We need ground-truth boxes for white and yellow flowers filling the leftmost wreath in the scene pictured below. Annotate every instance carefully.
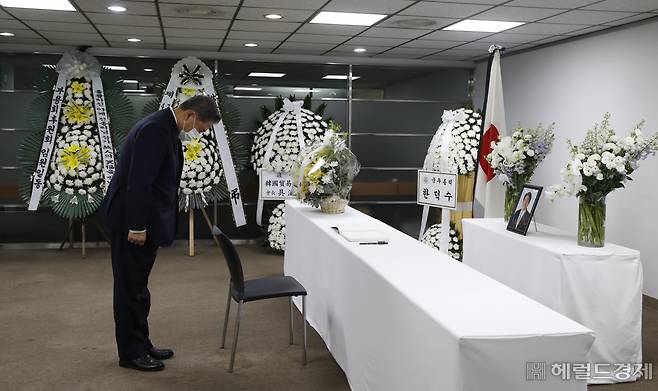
[48,79,105,205]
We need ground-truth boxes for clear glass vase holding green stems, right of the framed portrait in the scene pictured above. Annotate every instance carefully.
[578,197,605,247]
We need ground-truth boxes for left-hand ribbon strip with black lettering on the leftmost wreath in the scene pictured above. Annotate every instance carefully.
[27,73,67,211]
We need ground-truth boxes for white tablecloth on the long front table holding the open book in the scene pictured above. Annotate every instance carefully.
[284,201,594,391]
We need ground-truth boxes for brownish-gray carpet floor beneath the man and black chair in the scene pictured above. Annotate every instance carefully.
[0,243,658,391]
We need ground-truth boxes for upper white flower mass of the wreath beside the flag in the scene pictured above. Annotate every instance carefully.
[433,109,482,175]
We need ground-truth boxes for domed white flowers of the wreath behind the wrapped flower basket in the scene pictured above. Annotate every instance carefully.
[251,109,327,173]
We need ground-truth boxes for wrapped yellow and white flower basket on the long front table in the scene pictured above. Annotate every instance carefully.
[293,123,361,213]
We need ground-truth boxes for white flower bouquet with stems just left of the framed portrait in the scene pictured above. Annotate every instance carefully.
[487,124,555,221]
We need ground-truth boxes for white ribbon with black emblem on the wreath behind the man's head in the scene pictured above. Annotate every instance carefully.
[160,57,247,227]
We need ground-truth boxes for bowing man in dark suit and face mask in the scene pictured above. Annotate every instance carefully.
[102,95,220,371]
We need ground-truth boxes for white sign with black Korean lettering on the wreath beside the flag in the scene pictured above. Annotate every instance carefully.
[416,170,457,210]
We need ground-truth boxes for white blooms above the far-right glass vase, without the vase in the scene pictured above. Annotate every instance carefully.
[546,113,658,200]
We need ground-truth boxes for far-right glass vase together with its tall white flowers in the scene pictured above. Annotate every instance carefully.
[546,113,658,247]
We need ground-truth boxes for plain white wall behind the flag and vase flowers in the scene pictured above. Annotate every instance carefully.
[475,20,658,298]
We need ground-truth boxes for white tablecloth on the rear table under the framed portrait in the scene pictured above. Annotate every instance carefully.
[463,219,642,383]
